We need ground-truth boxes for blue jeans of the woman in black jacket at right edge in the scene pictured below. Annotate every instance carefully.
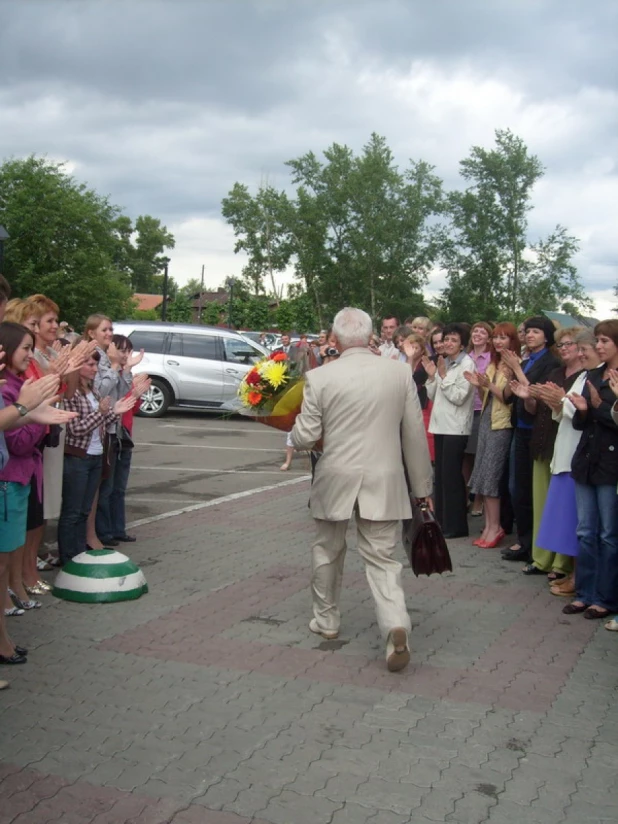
[575,483,618,612]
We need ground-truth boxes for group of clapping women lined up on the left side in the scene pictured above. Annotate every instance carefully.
[0,276,150,686]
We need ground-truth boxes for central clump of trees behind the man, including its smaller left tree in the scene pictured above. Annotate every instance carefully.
[223,134,442,326]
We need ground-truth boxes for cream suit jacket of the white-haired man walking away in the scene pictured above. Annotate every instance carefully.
[292,347,433,521]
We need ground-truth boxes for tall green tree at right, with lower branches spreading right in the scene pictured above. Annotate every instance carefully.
[439,130,590,321]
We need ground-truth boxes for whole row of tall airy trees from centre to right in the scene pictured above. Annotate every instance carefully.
[223,130,590,328]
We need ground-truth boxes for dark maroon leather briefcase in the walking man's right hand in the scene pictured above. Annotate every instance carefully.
[402,500,453,578]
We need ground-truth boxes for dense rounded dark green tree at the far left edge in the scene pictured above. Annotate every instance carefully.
[0,156,132,327]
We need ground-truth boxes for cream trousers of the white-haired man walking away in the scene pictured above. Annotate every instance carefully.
[311,513,411,640]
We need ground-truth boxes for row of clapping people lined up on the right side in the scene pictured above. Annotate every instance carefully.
[381,316,618,630]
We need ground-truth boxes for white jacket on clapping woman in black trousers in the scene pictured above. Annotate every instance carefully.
[425,354,476,435]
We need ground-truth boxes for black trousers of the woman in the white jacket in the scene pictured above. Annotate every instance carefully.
[434,435,468,537]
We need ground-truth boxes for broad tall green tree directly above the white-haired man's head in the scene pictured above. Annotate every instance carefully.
[288,134,442,325]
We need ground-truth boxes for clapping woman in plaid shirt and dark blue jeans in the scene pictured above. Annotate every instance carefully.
[58,351,136,564]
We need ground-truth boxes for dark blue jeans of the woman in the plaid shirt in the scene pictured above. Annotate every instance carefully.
[58,455,103,564]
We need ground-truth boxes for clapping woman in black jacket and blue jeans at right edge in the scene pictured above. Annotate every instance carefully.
[562,320,618,619]
